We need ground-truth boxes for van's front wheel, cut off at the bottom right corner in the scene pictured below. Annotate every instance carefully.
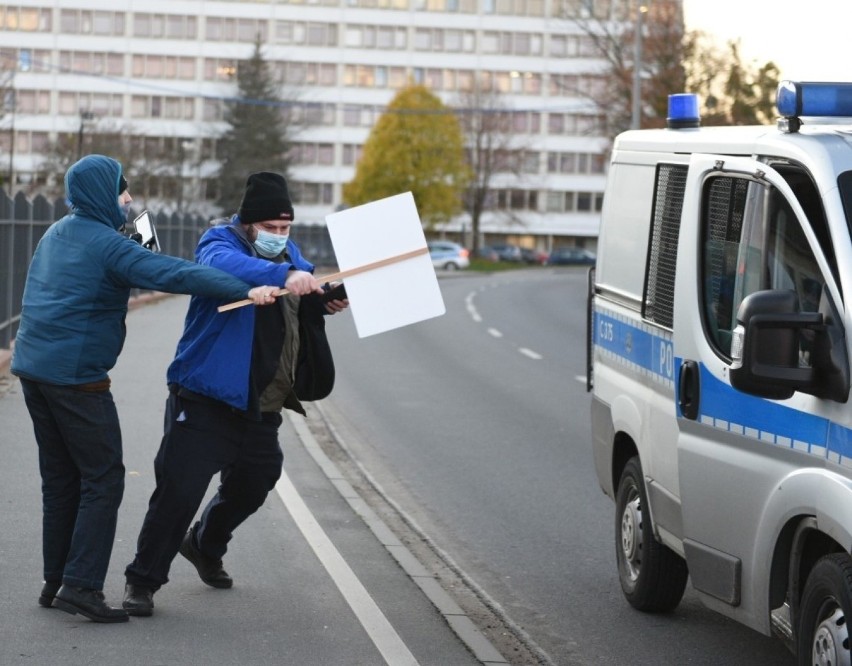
[797,553,852,666]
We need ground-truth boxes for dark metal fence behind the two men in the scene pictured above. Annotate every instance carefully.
[0,190,335,349]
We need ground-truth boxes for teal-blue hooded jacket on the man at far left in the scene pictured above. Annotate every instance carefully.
[11,155,249,385]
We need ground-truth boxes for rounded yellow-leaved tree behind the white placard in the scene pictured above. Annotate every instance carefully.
[343,85,470,225]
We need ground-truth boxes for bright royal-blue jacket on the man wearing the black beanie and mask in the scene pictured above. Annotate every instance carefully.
[167,216,314,410]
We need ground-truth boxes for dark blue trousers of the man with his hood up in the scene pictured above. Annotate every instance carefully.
[21,378,124,590]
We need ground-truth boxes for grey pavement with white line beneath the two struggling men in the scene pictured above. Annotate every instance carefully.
[0,297,507,666]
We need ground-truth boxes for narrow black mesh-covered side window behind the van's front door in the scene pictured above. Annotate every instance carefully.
[643,164,687,328]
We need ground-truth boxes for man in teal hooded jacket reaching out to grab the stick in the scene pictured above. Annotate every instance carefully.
[11,155,276,622]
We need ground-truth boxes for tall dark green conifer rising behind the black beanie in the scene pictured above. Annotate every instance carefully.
[216,39,295,213]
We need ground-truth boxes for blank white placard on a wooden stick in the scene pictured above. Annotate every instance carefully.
[325,192,446,338]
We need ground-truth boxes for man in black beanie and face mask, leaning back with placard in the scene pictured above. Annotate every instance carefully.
[123,172,348,616]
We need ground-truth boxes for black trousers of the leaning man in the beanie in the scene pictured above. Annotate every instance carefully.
[125,393,284,590]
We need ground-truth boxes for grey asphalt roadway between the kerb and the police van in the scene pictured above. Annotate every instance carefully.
[320,268,793,666]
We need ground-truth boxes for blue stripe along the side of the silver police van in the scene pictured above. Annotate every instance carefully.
[593,310,852,464]
